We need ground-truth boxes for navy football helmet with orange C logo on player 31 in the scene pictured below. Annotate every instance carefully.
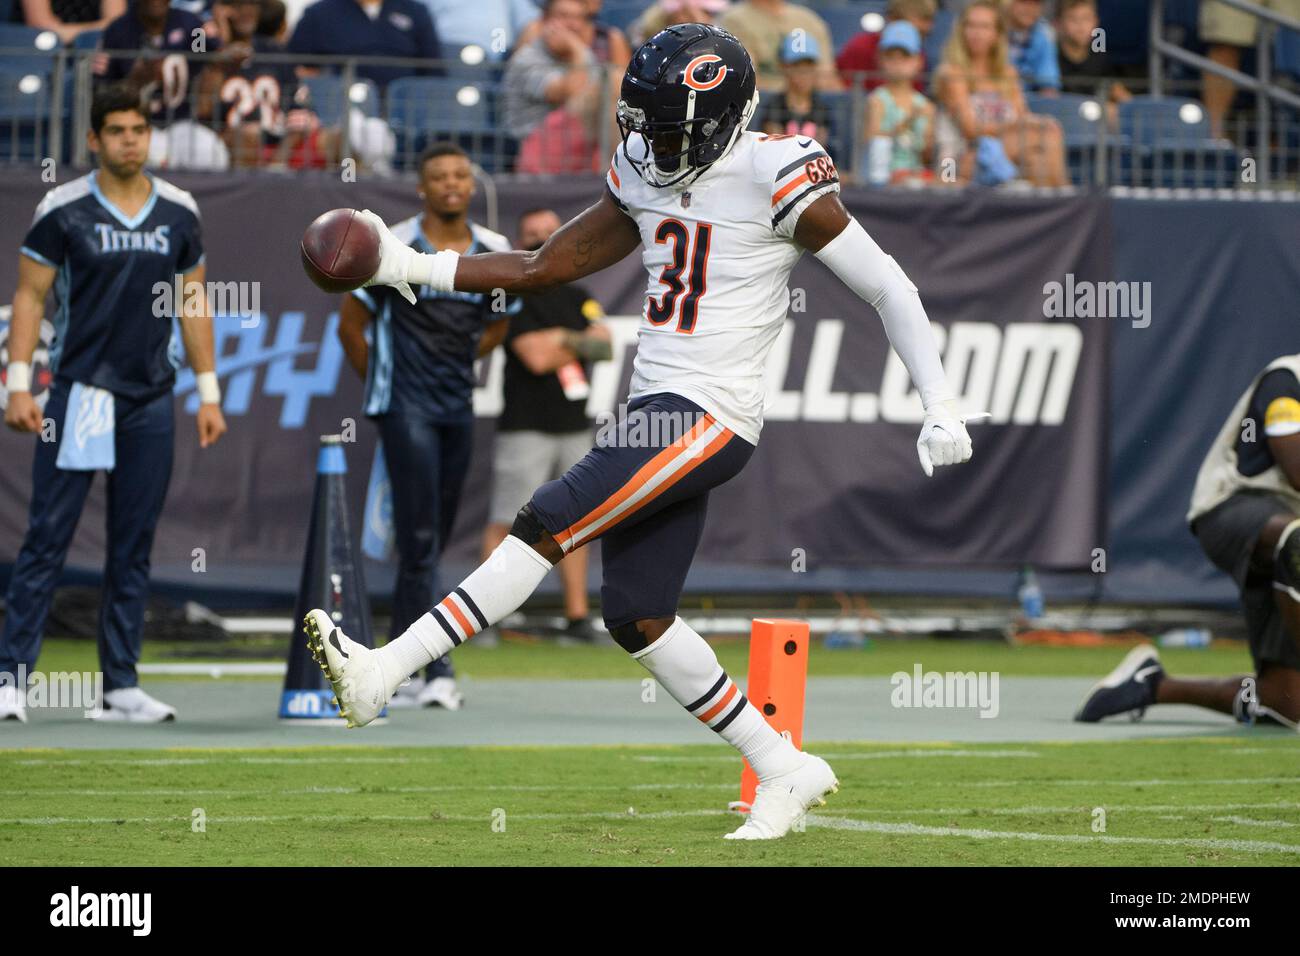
[618,23,758,187]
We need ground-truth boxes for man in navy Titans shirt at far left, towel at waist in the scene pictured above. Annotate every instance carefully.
[0,86,226,722]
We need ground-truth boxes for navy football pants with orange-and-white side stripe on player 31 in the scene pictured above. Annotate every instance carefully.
[529,393,754,628]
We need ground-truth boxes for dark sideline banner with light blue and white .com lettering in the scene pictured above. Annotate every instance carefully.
[12,167,1289,589]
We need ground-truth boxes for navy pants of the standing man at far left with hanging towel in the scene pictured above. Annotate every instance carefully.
[0,380,176,691]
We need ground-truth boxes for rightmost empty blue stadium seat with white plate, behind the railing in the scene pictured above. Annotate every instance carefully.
[1119,96,1238,187]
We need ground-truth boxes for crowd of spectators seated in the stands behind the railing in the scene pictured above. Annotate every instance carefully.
[12,0,1300,186]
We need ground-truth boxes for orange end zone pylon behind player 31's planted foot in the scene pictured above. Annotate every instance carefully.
[731,618,809,813]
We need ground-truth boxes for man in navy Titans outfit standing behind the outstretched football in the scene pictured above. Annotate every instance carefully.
[338,144,517,710]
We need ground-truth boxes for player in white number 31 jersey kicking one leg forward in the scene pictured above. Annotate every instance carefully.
[306,23,971,839]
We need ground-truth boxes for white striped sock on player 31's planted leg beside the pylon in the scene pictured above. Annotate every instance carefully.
[632,618,801,780]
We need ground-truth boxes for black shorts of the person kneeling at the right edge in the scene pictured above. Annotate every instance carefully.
[1192,492,1300,672]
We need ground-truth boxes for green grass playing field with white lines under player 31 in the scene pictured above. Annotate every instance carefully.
[0,641,1300,866]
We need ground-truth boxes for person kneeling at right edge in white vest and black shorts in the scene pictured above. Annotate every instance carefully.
[1076,355,1300,726]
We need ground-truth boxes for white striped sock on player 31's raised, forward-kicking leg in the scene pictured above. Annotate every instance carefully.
[380,535,551,676]
